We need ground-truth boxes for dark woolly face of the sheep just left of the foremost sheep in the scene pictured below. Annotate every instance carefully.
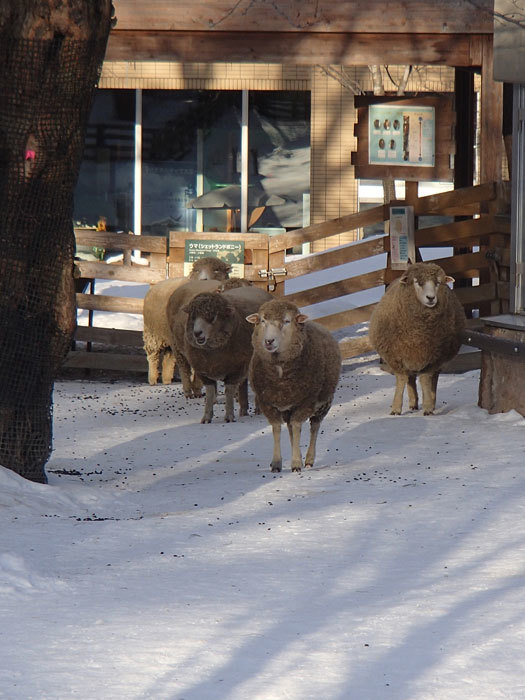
[183,293,235,349]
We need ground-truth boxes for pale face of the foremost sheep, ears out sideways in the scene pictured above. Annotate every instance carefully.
[246,301,308,356]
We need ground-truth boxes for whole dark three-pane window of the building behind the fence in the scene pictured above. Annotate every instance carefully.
[74,90,310,235]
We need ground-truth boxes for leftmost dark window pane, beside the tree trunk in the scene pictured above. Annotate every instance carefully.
[73,90,135,231]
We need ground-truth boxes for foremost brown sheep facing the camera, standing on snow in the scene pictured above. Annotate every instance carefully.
[246,299,341,472]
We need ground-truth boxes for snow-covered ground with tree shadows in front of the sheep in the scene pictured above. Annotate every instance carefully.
[0,266,525,700]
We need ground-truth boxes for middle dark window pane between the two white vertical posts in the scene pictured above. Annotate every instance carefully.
[142,90,241,235]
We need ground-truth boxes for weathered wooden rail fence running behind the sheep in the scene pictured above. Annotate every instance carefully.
[65,183,510,372]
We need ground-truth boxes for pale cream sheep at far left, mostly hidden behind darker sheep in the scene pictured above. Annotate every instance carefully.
[142,256,231,385]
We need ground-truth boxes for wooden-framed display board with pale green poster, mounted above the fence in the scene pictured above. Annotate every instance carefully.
[352,96,455,181]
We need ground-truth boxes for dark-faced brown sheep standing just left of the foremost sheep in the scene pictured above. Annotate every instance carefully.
[168,287,272,423]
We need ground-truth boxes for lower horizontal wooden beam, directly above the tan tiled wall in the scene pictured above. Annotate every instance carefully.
[105,30,484,66]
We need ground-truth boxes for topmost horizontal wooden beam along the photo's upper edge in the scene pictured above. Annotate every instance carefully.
[113,0,493,34]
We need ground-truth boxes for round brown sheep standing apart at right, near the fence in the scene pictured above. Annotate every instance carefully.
[369,263,466,416]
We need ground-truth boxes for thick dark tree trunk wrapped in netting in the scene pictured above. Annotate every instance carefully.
[0,0,112,482]
